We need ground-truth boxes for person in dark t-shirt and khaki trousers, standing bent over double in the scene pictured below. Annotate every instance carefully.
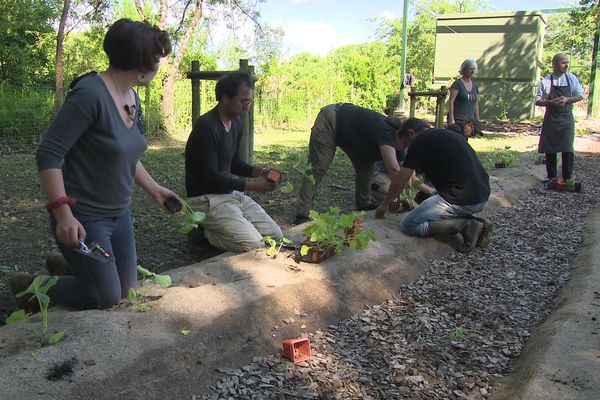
[293,103,401,224]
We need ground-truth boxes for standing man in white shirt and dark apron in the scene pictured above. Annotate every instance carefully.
[535,53,583,181]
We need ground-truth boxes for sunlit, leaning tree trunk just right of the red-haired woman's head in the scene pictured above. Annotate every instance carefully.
[160,0,202,133]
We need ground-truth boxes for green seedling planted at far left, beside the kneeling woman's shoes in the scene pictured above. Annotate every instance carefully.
[6,275,65,348]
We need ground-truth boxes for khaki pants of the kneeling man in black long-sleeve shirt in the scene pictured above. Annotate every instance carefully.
[188,192,283,253]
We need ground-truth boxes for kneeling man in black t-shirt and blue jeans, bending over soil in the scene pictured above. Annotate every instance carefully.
[375,118,492,252]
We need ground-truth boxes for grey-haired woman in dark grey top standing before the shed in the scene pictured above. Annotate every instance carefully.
[448,59,479,126]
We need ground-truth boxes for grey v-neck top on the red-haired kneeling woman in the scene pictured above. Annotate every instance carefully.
[36,74,147,217]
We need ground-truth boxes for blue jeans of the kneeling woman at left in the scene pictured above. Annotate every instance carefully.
[48,211,137,310]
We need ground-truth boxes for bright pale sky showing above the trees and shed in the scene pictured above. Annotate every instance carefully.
[260,0,576,56]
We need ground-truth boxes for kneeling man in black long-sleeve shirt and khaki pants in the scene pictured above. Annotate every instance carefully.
[185,72,283,253]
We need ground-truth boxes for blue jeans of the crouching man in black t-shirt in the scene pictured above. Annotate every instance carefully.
[400,194,487,237]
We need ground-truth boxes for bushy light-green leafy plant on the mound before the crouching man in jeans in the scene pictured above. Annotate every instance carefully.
[300,207,376,256]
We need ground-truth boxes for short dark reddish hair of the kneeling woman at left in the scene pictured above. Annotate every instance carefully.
[103,18,171,72]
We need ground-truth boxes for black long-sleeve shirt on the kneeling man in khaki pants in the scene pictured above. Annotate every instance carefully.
[185,107,253,197]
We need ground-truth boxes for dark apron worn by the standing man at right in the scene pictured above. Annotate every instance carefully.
[538,75,575,154]
